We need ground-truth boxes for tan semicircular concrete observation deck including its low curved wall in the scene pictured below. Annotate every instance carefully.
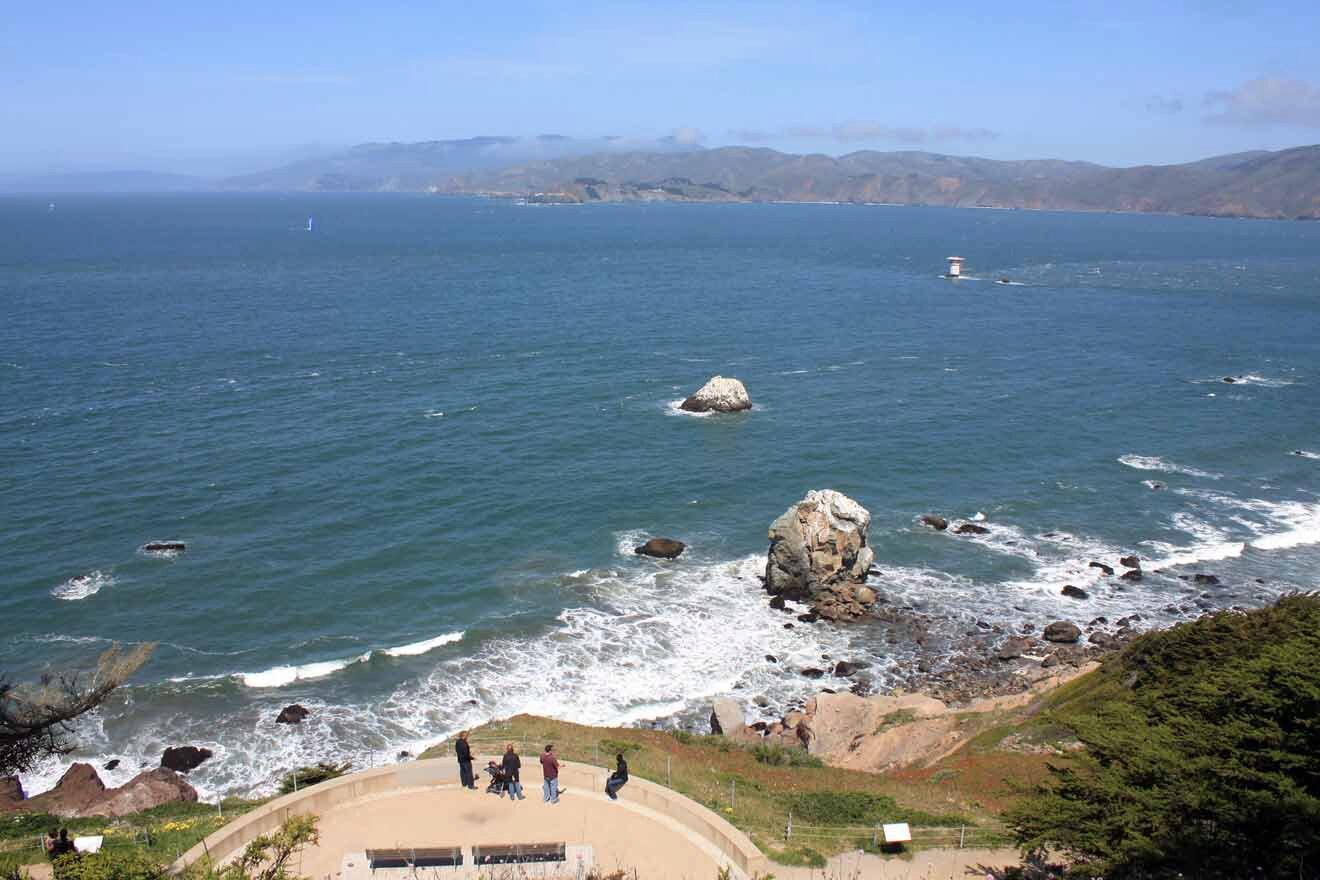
[173,755,770,880]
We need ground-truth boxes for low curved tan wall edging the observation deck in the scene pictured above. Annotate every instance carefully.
[170,757,770,877]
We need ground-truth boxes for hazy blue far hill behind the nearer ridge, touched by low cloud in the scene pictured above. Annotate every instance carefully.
[219,135,696,193]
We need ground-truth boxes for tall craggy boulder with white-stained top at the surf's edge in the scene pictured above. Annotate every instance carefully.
[766,489,875,620]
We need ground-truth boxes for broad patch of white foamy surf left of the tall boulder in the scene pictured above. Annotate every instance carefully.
[380,556,865,734]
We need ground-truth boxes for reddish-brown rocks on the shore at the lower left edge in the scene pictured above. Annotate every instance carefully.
[0,763,197,819]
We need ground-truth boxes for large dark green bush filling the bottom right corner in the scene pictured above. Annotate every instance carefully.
[1010,595,1320,880]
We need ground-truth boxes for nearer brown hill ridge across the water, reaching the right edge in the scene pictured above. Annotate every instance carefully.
[438,145,1320,219]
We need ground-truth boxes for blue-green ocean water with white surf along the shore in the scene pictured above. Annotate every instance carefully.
[0,195,1320,794]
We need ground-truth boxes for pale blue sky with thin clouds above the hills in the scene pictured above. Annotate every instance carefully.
[0,0,1320,175]
